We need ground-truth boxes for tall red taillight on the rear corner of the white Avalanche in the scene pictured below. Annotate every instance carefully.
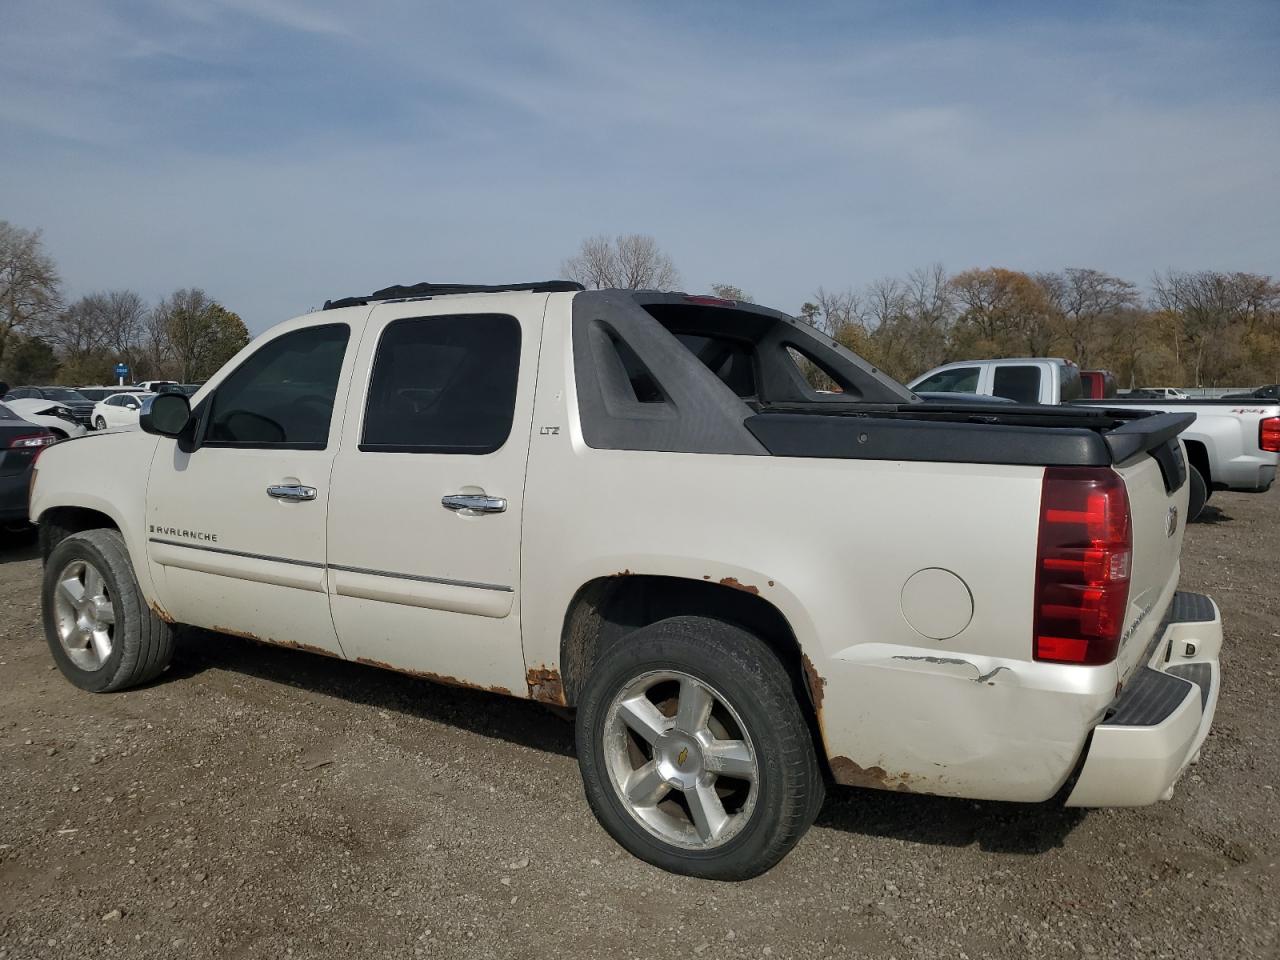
[1034,467,1133,664]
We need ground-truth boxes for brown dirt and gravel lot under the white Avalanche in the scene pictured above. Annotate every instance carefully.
[0,493,1280,960]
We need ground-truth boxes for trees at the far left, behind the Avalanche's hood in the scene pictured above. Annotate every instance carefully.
[0,220,250,385]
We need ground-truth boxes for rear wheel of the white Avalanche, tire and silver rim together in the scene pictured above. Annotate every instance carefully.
[577,617,823,879]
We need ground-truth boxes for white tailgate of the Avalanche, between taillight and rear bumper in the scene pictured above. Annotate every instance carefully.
[1115,439,1189,681]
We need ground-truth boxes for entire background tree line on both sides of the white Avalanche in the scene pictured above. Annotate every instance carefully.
[0,220,1280,387]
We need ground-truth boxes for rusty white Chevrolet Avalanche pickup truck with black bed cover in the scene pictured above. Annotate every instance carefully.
[31,282,1222,879]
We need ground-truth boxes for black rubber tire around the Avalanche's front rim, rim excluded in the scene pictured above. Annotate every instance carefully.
[41,530,173,694]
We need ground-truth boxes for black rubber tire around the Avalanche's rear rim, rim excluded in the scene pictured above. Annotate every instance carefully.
[576,617,824,881]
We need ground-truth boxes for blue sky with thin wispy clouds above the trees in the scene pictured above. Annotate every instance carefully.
[0,0,1280,332]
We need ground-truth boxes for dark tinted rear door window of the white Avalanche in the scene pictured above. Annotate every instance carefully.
[360,314,520,454]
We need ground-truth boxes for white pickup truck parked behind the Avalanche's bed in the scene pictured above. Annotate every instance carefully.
[910,357,1280,520]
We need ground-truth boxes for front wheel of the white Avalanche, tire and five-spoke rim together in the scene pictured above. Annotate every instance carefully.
[41,530,173,692]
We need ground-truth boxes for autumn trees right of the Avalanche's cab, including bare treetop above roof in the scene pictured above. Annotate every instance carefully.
[562,236,1280,387]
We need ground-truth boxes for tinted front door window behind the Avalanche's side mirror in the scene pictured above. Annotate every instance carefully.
[205,324,349,449]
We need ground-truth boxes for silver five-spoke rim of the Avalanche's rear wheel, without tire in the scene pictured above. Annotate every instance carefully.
[603,671,760,850]
